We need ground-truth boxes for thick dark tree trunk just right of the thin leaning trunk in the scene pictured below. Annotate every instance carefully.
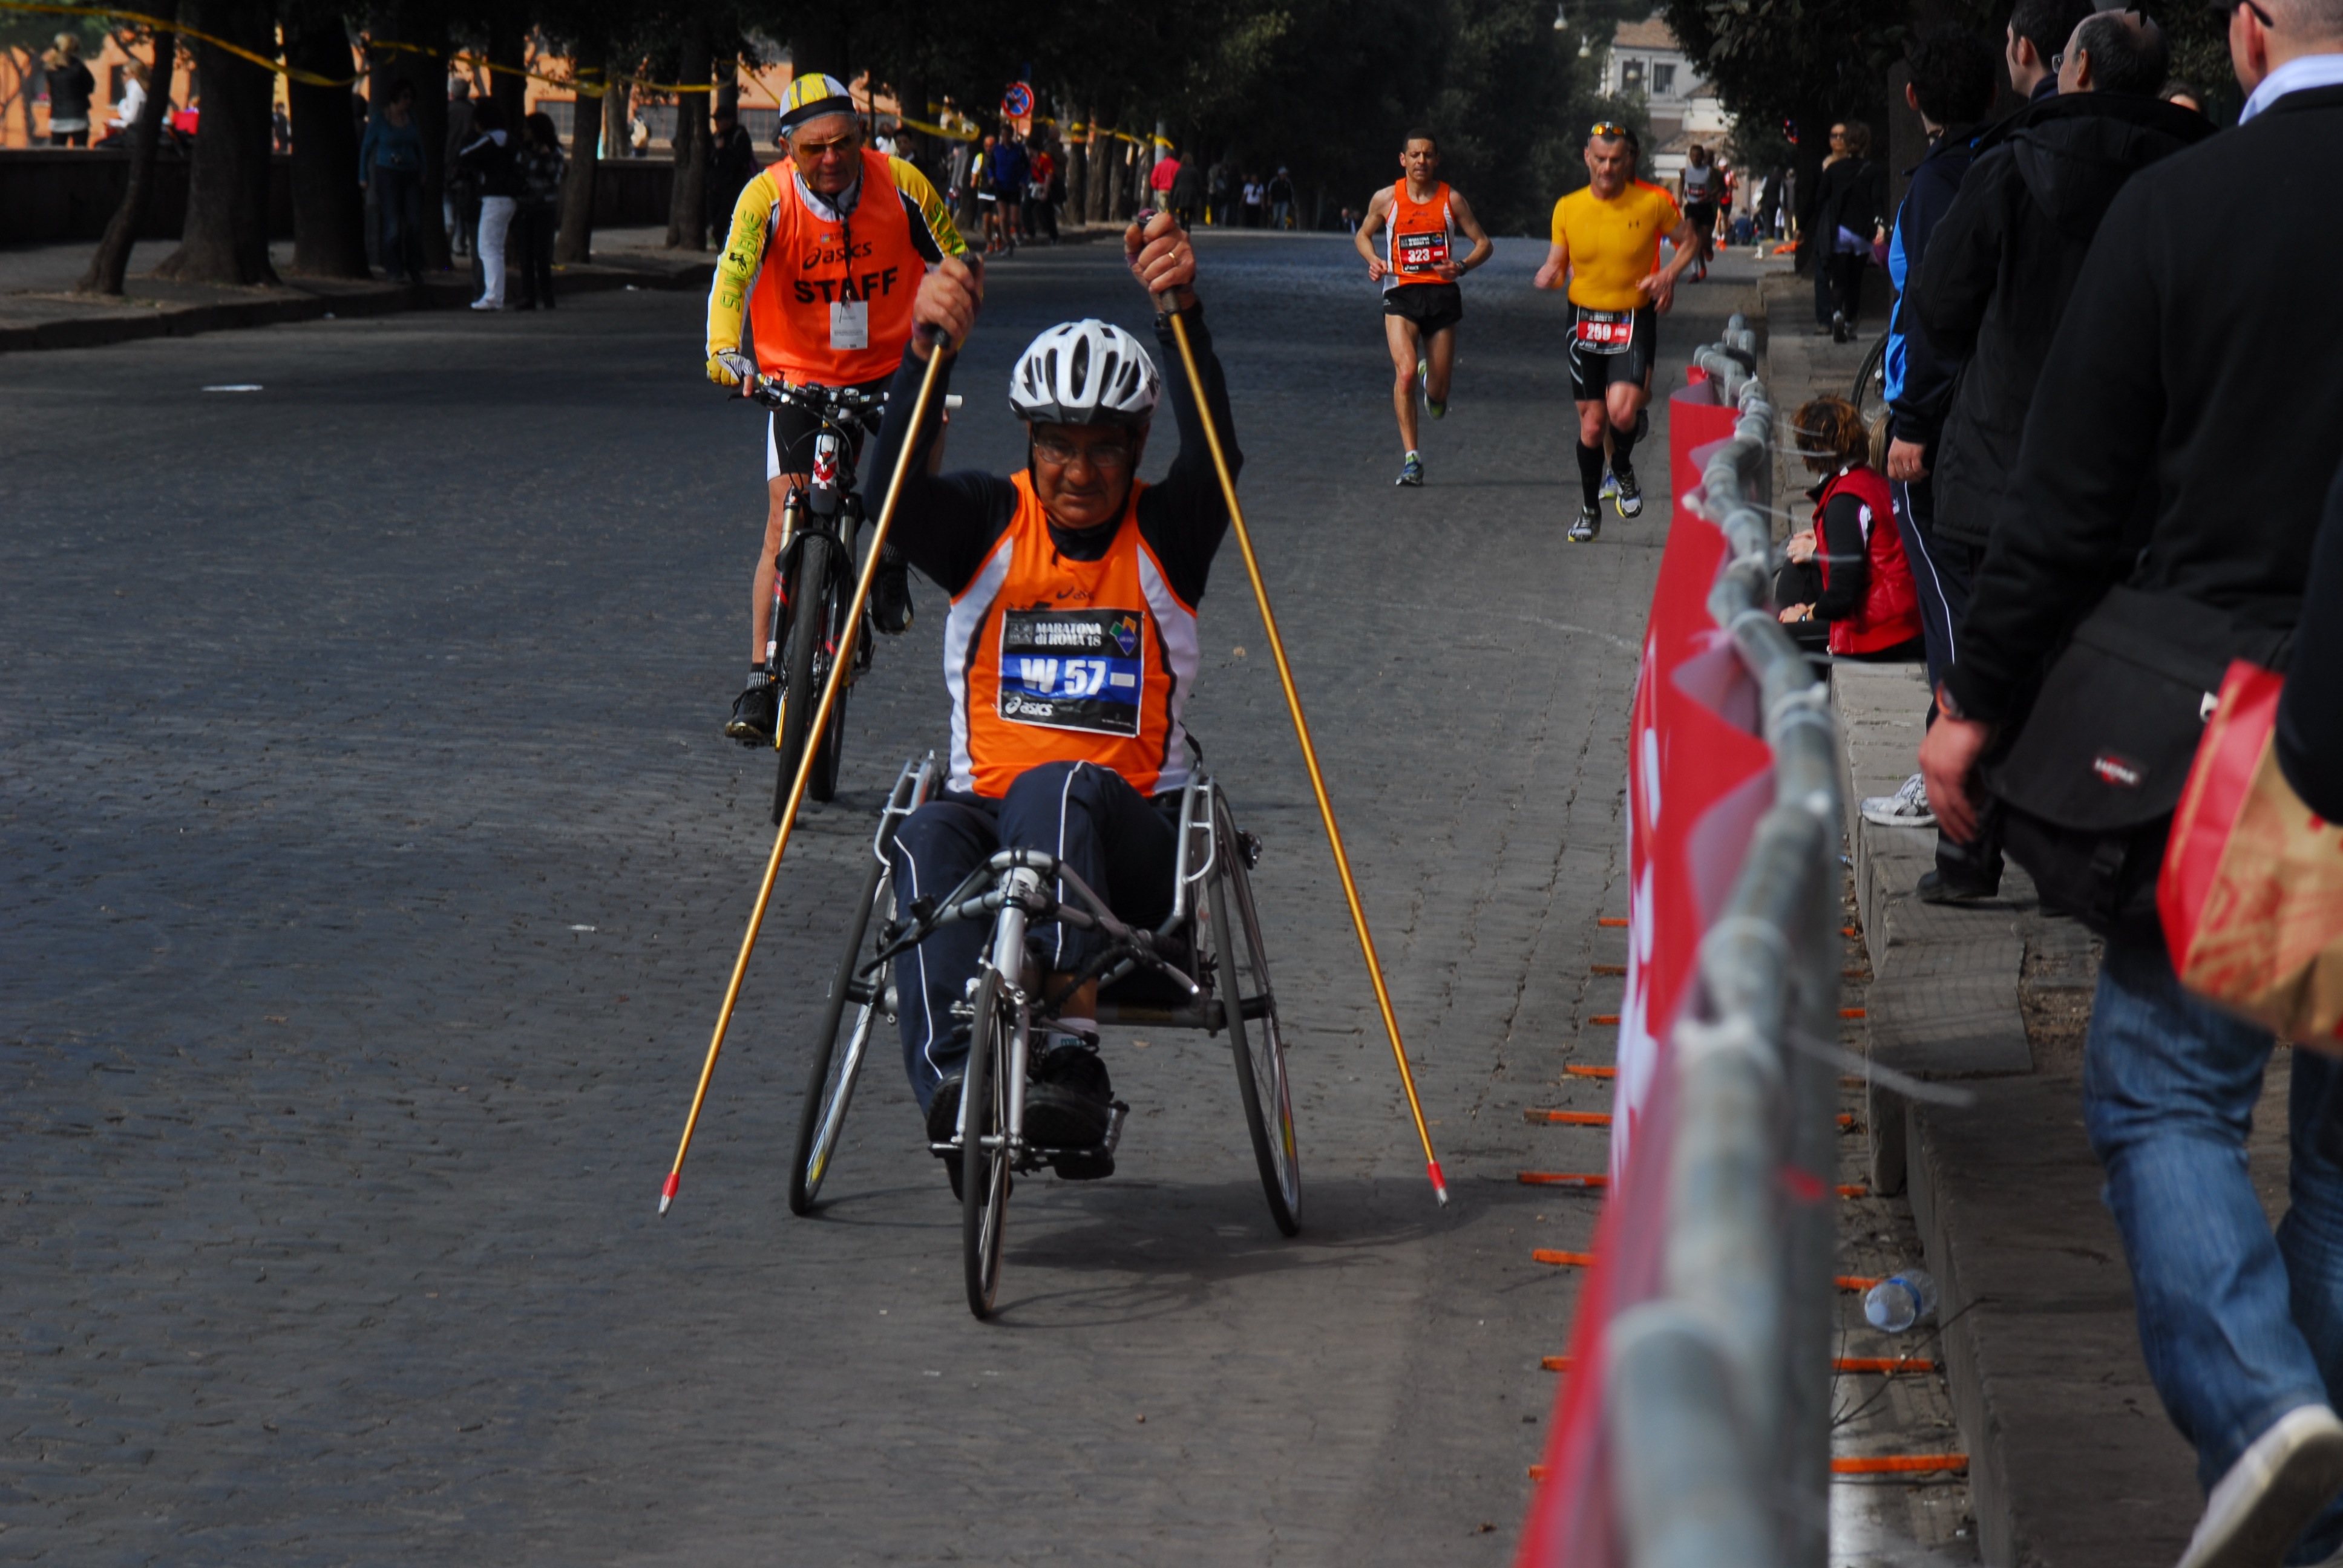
[155,0,278,286]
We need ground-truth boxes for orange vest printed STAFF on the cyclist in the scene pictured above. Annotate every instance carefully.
[747,148,928,387]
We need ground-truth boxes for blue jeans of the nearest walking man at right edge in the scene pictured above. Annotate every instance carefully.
[2083,940,2343,1563]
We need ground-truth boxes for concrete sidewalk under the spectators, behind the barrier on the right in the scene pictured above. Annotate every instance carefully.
[1766,279,2287,1568]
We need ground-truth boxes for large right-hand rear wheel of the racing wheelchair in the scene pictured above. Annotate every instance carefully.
[1207,792,1303,1235]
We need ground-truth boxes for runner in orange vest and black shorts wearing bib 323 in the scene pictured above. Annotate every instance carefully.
[1352,131,1497,485]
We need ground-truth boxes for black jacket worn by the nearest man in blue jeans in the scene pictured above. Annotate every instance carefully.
[1928,87,2343,727]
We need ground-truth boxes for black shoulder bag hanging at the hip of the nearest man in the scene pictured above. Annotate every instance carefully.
[1985,588,2289,940]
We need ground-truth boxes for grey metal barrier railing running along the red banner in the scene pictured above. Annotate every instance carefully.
[1605,316,1840,1568]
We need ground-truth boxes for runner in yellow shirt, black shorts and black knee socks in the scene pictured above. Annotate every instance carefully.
[1535,122,1701,544]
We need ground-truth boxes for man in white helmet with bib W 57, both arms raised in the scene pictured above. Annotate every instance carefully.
[874,214,1239,1191]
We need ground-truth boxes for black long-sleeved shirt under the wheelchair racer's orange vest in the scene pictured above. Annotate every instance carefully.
[865,309,1244,607]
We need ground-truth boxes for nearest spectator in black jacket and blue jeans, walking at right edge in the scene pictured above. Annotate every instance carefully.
[1921,0,2343,1568]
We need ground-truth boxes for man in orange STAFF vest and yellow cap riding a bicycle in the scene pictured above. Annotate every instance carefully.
[707,75,968,745]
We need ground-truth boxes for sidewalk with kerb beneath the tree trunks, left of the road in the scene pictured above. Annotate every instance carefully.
[0,230,715,354]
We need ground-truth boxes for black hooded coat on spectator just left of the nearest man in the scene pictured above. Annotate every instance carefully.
[1912,94,2212,549]
